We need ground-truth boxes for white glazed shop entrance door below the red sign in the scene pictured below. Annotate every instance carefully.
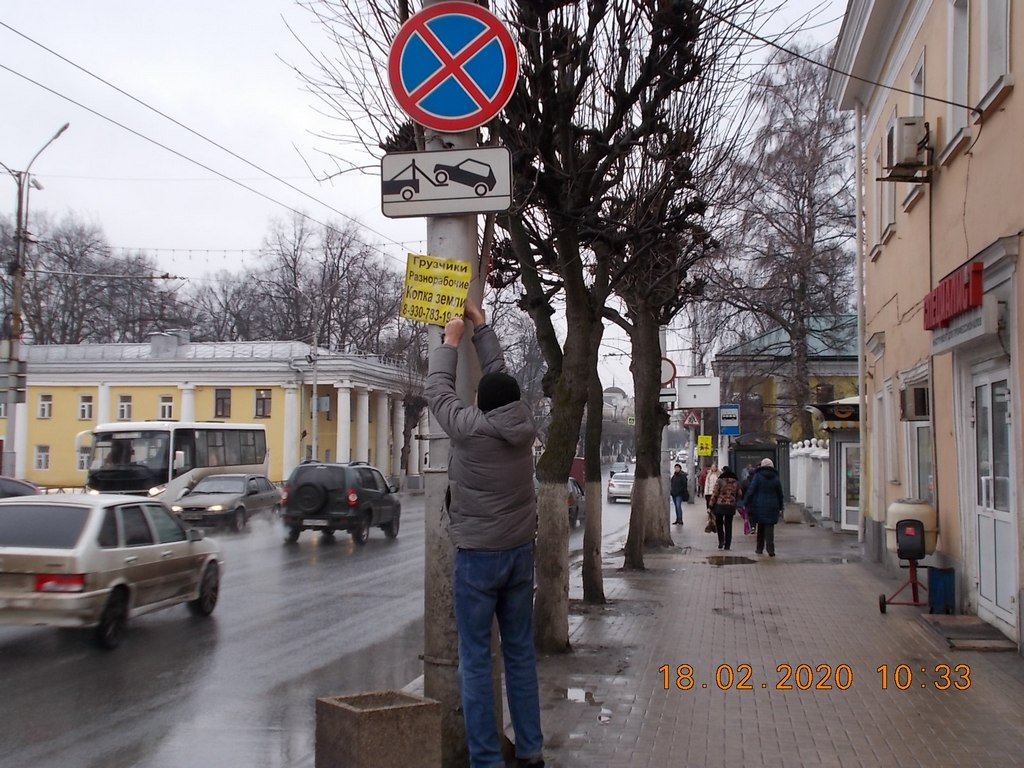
[973,369,1017,639]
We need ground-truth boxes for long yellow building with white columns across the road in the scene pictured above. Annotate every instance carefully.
[0,331,425,487]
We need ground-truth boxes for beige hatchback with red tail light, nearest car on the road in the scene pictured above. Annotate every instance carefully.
[0,494,224,648]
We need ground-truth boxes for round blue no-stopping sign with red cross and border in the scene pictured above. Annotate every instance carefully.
[388,1,519,133]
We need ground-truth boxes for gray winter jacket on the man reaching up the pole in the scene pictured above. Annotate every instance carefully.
[424,325,537,550]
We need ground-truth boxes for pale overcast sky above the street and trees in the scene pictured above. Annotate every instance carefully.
[0,0,846,391]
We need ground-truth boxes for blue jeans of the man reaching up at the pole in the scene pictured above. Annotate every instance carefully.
[455,544,544,768]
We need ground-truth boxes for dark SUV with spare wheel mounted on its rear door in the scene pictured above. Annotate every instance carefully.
[281,462,401,544]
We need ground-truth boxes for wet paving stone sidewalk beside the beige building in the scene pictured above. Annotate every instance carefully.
[540,505,1024,768]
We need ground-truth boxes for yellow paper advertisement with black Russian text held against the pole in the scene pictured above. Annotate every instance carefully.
[398,253,472,328]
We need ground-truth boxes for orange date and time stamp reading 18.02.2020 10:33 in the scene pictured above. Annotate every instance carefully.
[657,664,971,690]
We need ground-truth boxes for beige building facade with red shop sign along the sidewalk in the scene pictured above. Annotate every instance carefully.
[829,0,1024,646]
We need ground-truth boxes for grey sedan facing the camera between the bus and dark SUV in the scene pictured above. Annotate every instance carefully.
[171,474,281,530]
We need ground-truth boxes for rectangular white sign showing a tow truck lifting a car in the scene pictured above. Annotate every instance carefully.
[381,146,512,218]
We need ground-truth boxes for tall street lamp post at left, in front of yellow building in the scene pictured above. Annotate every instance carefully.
[0,123,71,476]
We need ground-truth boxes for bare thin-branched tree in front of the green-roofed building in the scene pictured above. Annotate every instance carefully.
[708,49,855,437]
